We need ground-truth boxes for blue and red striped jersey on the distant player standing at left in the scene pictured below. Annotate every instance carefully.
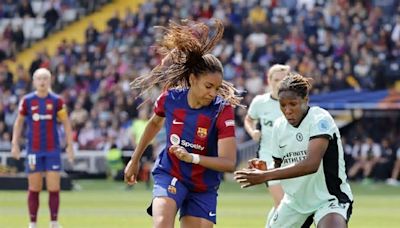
[19,92,64,153]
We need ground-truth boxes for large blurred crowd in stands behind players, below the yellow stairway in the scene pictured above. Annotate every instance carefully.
[0,0,400,183]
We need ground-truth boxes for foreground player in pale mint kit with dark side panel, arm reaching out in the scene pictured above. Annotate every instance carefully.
[235,73,353,227]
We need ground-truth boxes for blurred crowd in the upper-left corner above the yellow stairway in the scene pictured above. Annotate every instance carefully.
[0,0,109,62]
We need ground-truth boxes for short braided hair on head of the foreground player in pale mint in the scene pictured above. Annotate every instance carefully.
[278,72,312,98]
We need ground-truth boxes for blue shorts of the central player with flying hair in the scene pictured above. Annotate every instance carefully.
[148,173,218,224]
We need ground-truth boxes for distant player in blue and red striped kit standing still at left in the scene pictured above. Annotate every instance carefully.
[11,68,74,228]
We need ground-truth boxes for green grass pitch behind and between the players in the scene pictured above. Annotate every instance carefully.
[0,180,400,228]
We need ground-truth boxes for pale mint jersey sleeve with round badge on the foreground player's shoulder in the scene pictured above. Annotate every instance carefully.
[310,112,336,139]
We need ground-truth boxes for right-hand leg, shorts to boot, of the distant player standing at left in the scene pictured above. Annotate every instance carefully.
[45,156,61,228]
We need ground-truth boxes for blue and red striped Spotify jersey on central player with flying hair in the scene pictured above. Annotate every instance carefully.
[154,89,235,192]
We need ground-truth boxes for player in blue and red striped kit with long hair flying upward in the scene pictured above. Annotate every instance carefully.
[125,21,240,228]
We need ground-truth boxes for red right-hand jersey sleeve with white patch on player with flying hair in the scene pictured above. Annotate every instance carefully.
[216,105,235,139]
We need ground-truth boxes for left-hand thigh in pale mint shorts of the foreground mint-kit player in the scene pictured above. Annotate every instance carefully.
[268,201,312,228]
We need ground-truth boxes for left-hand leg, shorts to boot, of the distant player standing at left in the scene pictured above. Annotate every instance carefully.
[25,154,44,228]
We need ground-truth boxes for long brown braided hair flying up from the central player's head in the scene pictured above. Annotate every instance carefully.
[131,20,242,106]
